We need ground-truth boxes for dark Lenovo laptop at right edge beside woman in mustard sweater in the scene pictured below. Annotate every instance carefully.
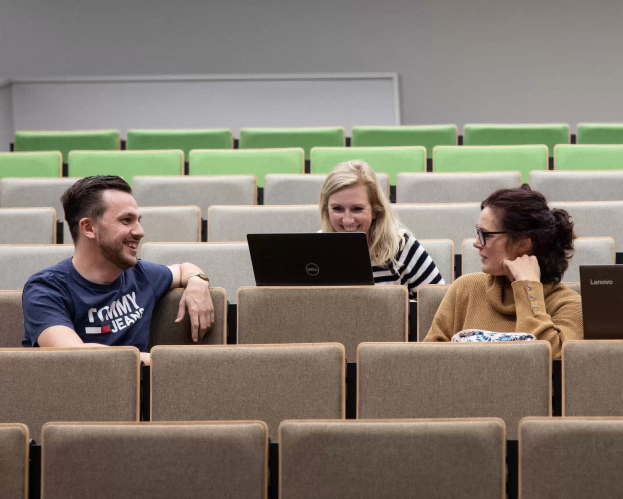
[580,265,623,340]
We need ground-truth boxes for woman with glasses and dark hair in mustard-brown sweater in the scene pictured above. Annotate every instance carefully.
[425,184,583,358]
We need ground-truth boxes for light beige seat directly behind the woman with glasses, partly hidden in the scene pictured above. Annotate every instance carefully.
[462,237,615,283]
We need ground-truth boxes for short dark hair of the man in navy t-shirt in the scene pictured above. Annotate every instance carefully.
[61,175,132,244]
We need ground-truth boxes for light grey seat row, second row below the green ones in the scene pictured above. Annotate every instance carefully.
[0,198,623,268]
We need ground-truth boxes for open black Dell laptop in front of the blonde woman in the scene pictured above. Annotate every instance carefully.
[247,232,374,286]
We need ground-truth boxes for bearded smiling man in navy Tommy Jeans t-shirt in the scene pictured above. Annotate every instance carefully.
[22,176,214,364]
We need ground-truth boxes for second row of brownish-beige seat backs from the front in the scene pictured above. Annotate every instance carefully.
[0,340,623,442]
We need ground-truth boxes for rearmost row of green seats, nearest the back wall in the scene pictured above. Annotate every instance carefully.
[14,123,623,161]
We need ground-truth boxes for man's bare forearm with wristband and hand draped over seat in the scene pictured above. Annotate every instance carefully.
[169,263,214,342]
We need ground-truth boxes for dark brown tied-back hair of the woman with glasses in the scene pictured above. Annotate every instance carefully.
[480,184,575,284]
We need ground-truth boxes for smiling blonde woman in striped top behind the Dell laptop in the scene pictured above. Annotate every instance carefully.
[320,160,444,299]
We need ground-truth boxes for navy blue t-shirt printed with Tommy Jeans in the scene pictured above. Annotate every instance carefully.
[22,258,173,352]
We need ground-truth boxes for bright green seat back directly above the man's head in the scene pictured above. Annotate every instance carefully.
[68,150,184,185]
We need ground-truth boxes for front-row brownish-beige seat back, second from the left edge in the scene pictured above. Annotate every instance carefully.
[42,421,268,499]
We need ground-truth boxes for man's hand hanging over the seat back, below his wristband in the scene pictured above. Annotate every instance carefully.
[175,277,214,343]
